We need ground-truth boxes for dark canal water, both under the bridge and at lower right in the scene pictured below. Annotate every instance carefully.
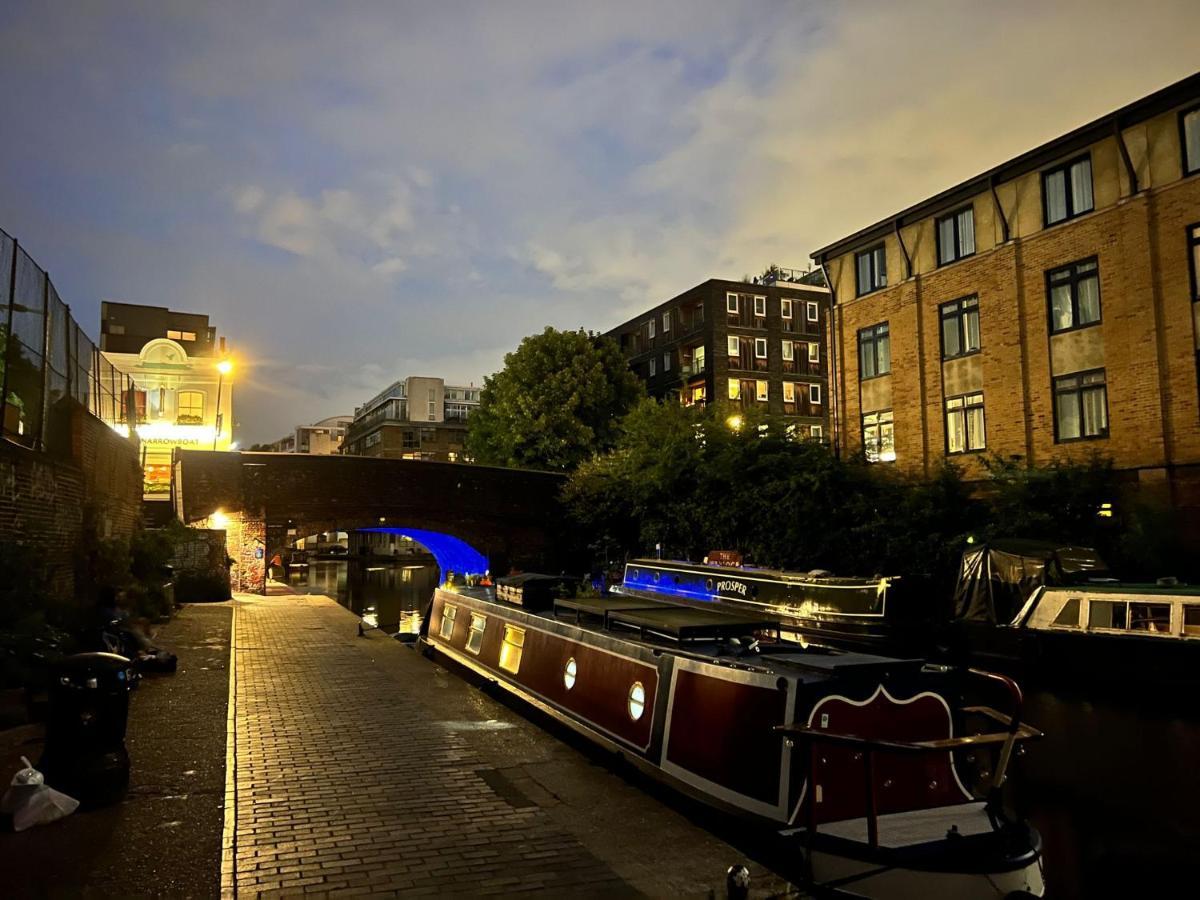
[289,560,1200,900]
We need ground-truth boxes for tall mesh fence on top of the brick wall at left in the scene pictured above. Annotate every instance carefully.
[0,230,133,449]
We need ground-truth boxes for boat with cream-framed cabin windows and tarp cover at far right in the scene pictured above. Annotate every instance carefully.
[950,541,1200,684]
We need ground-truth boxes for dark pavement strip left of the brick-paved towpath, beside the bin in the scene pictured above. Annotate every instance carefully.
[0,604,232,898]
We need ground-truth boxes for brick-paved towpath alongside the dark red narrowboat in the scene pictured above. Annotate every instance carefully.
[223,596,782,896]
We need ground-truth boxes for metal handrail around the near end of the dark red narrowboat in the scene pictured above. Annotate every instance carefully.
[775,668,1043,847]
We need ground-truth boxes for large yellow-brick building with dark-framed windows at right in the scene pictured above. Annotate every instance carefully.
[812,74,1200,518]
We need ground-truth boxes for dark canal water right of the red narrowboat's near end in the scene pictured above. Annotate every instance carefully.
[1016,685,1200,898]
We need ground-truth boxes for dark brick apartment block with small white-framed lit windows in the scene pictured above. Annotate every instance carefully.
[607,278,829,438]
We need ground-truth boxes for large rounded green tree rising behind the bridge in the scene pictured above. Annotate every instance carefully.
[467,328,643,470]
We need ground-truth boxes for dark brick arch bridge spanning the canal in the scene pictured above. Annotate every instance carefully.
[172,450,570,593]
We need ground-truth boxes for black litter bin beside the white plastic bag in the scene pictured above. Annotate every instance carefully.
[37,653,137,806]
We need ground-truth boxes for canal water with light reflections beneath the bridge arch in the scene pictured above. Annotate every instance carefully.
[288,559,438,635]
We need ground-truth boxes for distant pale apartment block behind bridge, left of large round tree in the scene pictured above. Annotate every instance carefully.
[342,376,480,462]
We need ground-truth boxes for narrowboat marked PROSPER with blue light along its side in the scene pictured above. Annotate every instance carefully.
[613,554,911,650]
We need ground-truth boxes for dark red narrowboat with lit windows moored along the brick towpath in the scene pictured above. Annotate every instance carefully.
[421,587,1043,900]
